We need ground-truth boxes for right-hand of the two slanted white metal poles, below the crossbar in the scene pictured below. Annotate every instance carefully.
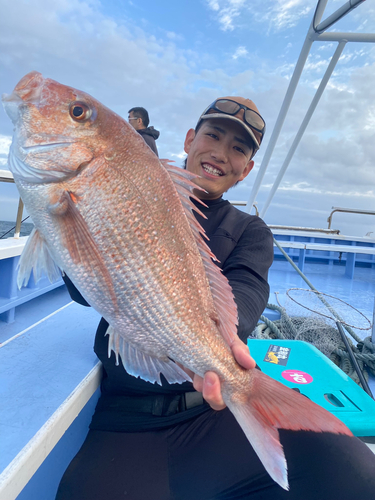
[260,41,346,222]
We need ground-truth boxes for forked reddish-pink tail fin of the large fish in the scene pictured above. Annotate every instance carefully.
[227,370,352,490]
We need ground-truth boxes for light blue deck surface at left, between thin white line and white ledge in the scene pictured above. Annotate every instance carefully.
[0,303,100,472]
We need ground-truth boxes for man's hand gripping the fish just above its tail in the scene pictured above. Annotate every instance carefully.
[186,338,256,410]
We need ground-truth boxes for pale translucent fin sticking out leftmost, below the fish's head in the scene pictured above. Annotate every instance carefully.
[17,228,61,289]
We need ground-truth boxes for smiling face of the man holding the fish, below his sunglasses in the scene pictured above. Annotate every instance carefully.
[185,118,254,200]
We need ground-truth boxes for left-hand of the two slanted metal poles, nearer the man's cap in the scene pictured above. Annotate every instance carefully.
[245,0,328,213]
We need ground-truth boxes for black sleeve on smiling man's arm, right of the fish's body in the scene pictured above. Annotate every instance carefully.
[223,224,273,342]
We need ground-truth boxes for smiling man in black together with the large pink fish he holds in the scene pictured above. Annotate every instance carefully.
[4,72,375,500]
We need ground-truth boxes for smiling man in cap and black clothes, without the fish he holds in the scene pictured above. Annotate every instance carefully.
[56,97,374,500]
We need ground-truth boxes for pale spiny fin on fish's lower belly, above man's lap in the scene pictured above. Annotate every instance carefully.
[106,326,192,385]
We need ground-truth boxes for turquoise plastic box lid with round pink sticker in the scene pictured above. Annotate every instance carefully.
[247,339,375,436]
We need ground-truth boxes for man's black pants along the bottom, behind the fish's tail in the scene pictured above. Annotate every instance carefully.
[56,410,375,500]
